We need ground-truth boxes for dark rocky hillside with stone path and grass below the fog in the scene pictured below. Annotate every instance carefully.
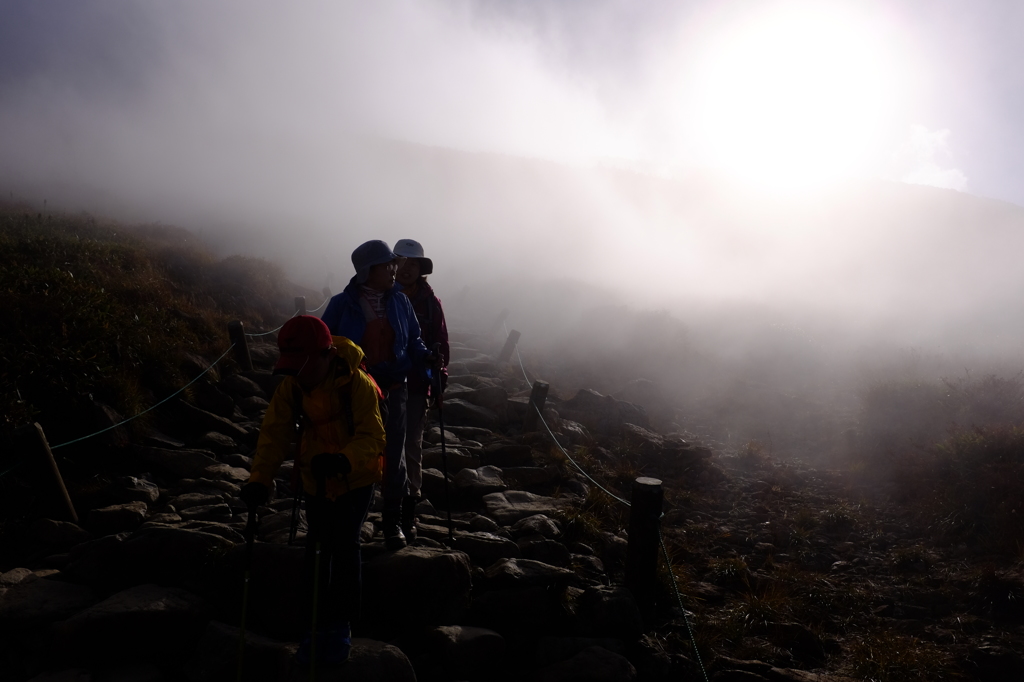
[0,207,1024,682]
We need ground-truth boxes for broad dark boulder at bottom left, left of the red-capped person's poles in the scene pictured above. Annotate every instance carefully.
[54,584,207,662]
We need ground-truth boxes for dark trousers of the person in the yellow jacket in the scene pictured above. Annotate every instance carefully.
[303,484,374,629]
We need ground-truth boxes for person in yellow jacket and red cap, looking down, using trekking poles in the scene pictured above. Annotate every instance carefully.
[240,315,384,664]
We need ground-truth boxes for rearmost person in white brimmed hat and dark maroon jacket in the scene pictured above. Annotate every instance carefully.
[394,240,451,538]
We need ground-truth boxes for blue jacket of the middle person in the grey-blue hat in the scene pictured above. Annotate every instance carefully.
[322,278,430,388]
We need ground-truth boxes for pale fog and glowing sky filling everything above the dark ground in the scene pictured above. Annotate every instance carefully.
[0,1,1024,450]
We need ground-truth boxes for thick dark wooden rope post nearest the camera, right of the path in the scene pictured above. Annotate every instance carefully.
[626,476,665,623]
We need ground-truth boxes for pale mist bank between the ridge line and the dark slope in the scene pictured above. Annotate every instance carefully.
[8,137,1024,454]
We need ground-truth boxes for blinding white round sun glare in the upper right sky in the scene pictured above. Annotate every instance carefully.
[696,6,892,189]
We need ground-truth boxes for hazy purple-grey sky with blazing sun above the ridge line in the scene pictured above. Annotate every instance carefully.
[0,0,1024,204]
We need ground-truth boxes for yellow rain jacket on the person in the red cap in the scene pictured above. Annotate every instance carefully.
[249,336,384,500]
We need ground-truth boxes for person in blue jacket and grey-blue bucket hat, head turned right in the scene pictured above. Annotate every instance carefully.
[323,240,435,549]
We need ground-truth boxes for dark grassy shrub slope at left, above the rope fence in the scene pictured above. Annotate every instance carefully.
[0,206,295,442]
